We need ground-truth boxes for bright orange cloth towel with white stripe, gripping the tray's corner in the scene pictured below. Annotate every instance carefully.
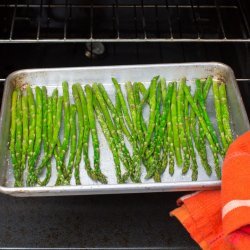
[170,132,250,250]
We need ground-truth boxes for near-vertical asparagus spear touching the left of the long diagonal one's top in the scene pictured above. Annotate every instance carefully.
[177,78,190,174]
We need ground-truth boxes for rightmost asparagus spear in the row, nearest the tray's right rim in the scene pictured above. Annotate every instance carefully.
[219,83,233,145]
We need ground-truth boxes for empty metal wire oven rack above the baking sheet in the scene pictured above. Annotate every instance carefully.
[0,0,250,43]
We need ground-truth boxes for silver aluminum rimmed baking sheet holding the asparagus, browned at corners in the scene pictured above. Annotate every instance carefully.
[0,62,249,196]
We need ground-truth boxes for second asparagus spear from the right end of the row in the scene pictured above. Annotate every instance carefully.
[213,81,228,151]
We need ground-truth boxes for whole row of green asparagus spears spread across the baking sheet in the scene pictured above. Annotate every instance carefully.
[10,76,233,187]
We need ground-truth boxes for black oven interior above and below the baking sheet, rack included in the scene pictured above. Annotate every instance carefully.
[0,0,250,249]
